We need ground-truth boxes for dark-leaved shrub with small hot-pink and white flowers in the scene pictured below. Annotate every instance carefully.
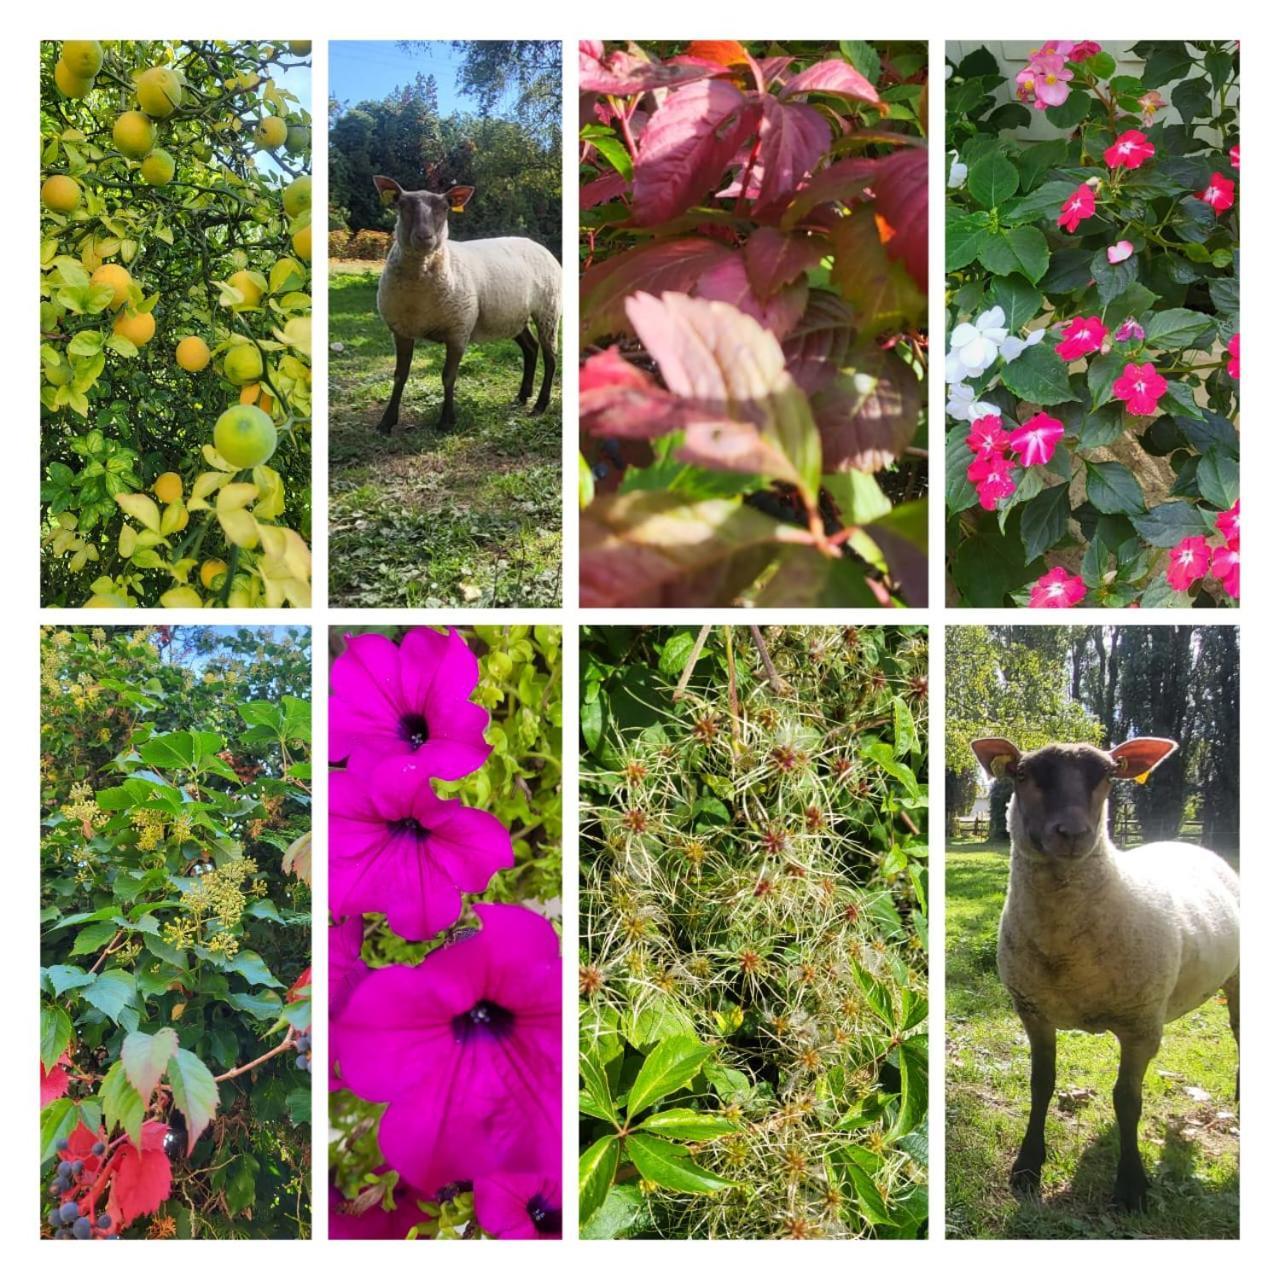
[946,41,1240,608]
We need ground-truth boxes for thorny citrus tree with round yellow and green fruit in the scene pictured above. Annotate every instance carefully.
[38,40,311,608]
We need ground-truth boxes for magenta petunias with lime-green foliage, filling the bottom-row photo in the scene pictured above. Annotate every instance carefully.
[329,627,562,1239]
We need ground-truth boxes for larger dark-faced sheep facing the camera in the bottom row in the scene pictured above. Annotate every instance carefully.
[972,737,1240,1211]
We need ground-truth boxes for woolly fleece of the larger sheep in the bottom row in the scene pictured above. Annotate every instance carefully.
[998,842,1240,1033]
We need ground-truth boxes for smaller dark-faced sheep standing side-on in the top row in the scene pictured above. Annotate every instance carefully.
[374,175,561,433]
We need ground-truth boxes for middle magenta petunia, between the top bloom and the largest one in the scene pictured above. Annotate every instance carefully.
[329,755,515,942]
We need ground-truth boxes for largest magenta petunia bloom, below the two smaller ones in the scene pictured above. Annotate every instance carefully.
[332,902,561,1194]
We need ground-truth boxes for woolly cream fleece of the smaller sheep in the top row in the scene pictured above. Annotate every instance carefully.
[378,236,561,347]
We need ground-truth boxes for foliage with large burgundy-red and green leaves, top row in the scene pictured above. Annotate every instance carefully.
[579,40,928,605]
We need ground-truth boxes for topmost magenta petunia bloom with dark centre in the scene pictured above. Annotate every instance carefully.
[329,627,492,781]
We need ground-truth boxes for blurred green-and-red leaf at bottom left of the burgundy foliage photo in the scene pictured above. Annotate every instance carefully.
[579,490,809,608]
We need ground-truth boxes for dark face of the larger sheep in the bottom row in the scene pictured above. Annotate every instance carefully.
[1007,745,1116,859]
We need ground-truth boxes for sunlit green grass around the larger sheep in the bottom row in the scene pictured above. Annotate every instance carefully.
[946,845,1240,1239]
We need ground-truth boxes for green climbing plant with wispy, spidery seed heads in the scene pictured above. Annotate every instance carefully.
[579,627,928,1239]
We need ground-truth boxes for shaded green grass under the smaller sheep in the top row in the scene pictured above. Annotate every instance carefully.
[329,268,561,608]
